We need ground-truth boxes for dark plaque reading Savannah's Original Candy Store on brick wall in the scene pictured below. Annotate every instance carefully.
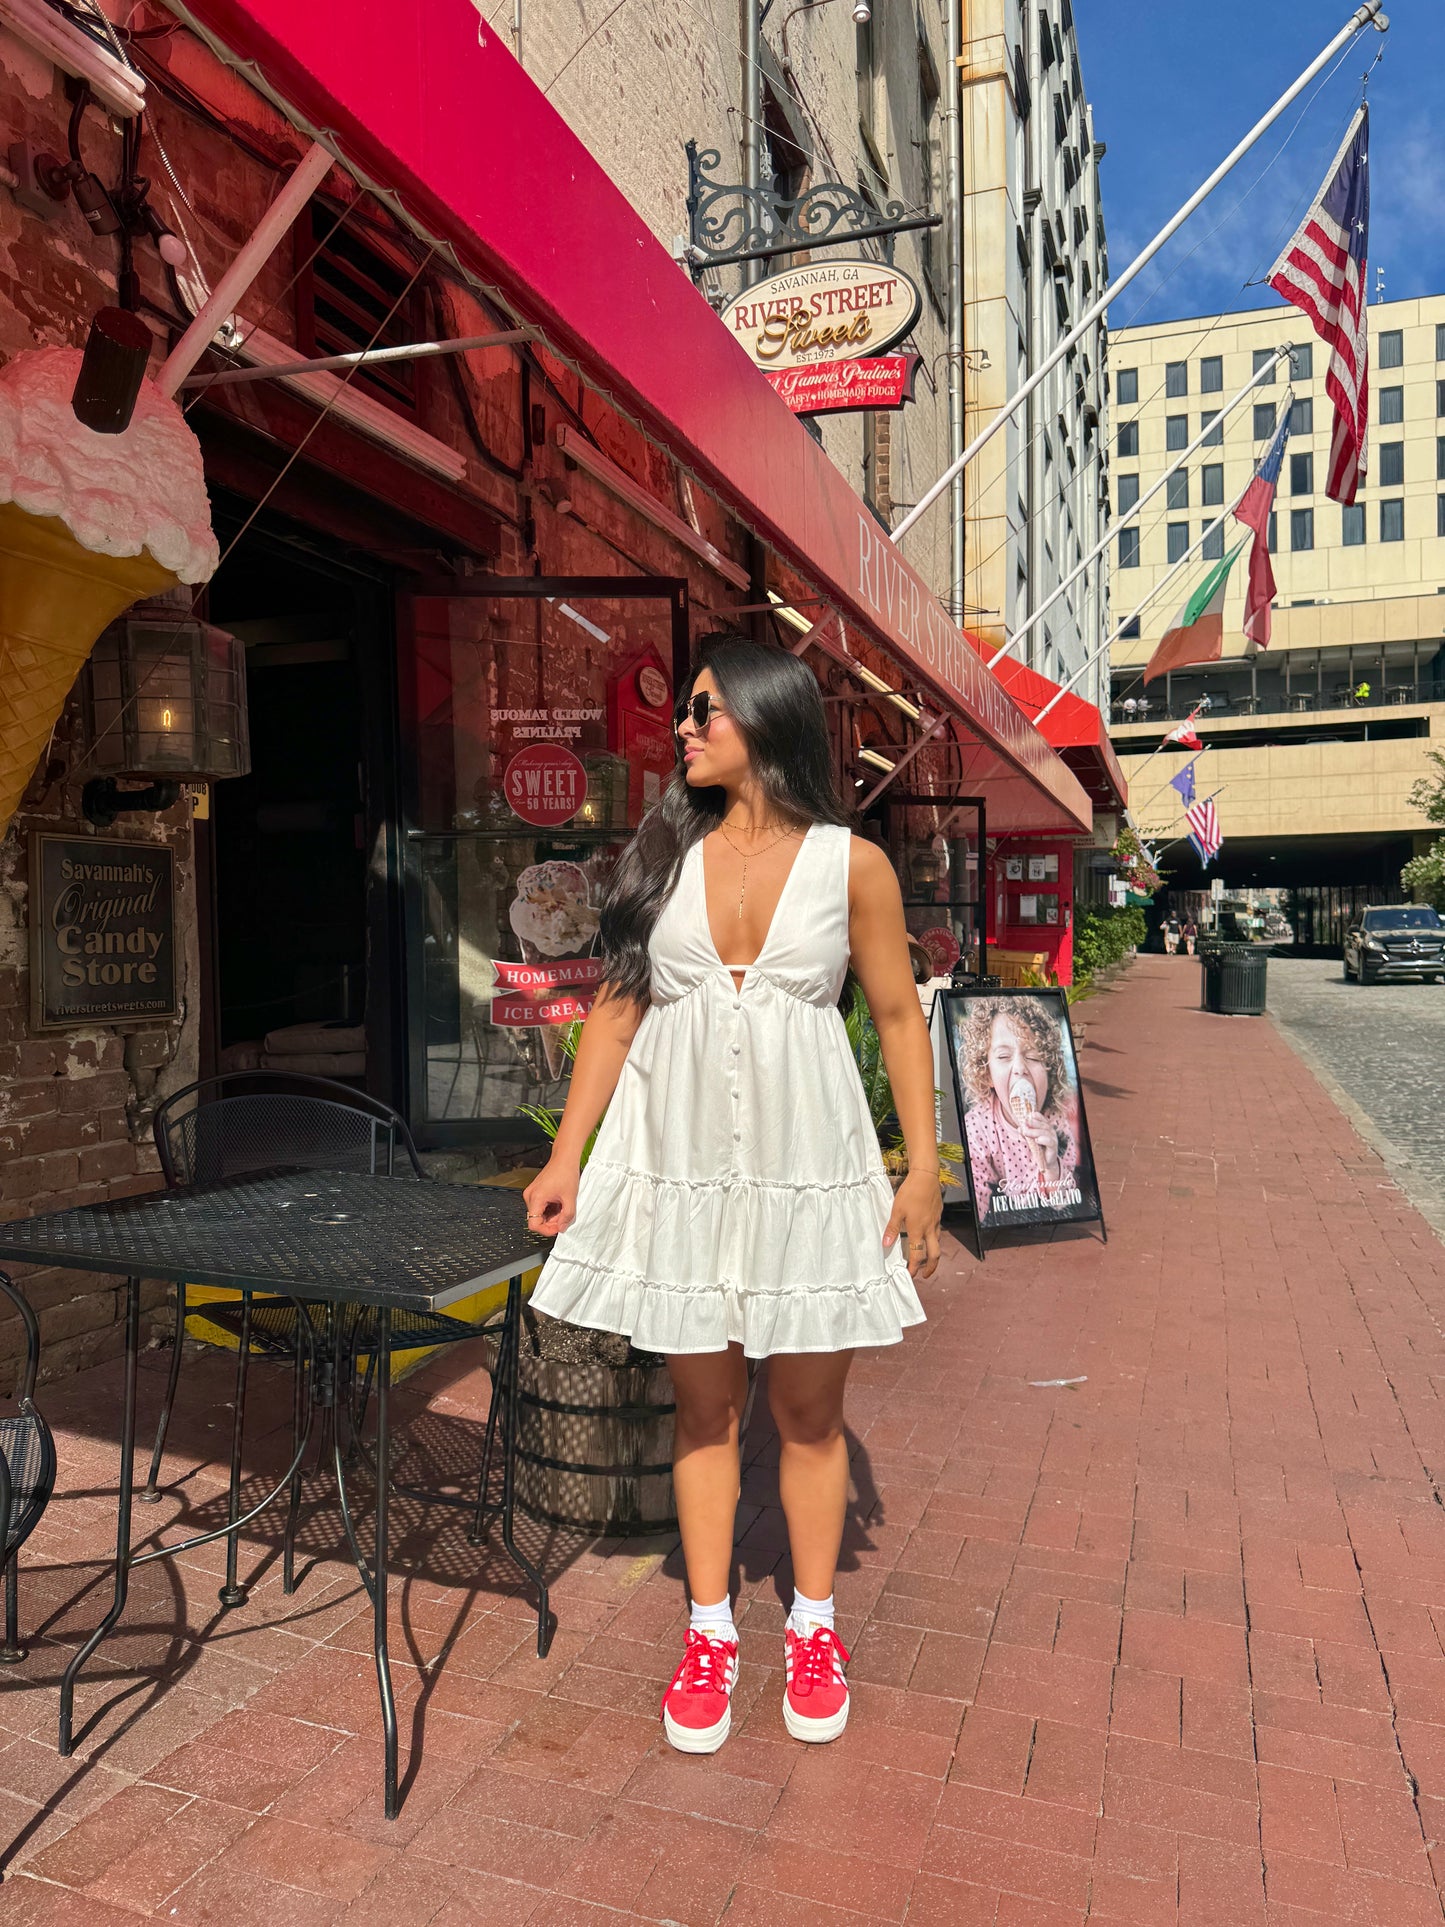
[31,832,179,1031]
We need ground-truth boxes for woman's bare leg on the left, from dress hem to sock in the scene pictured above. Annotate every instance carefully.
[667,1345,748,1605]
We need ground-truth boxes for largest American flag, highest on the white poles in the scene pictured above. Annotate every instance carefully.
[1270,106,1370,507]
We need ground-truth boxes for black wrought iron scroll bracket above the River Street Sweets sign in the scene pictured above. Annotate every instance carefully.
[686,141,942,281]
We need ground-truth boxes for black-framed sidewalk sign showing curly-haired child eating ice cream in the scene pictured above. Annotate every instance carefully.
[940,990,1104,1231]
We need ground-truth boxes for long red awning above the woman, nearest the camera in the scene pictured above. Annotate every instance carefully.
[168,0,1090,831]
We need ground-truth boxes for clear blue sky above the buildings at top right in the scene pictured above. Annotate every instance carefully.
[1073,0,1445,328]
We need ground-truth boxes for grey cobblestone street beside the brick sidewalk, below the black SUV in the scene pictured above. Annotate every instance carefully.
[1270,958,1445,1231]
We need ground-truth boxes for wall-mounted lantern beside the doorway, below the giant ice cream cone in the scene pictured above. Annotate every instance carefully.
[81,590,250,827]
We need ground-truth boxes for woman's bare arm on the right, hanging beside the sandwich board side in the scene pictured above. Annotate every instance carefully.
[848,836,942,1278]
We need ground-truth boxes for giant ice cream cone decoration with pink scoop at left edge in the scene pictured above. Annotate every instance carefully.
[0,349,216,834]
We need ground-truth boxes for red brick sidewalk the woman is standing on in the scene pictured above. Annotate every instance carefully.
[0,958,1445,1927]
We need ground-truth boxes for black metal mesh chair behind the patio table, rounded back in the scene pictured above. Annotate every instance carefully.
[137,1071,516,1592]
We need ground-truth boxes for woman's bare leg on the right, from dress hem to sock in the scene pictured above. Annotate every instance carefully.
[767,1351,854,1599]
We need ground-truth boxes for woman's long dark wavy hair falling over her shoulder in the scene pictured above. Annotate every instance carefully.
[601,634,850,1004]
